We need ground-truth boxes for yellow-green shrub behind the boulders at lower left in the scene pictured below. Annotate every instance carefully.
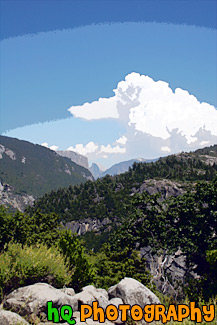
[0,243,73,295]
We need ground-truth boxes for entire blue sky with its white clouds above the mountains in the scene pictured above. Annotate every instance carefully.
[0,0,217,166]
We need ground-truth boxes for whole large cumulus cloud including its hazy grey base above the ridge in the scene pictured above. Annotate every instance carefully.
[69,72,217,159]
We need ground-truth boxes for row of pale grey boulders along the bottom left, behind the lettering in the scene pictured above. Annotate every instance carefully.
[0,278,160,325]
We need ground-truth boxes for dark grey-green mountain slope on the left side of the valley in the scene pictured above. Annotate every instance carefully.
[0,136,92,204]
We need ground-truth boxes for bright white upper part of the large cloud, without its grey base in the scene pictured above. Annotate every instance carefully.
[69,72,217,145]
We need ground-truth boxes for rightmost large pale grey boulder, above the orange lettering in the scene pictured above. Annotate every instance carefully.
[108,278,160,308]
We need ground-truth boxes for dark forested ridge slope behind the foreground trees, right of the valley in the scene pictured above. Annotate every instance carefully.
[28,145,217,222]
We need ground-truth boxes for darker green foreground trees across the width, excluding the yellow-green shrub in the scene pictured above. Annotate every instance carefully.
[0,178,214,301]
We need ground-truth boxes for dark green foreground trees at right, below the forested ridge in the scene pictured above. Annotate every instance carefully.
[110,177,217,300]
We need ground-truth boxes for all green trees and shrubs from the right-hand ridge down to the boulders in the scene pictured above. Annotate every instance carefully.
[0,146,217,306]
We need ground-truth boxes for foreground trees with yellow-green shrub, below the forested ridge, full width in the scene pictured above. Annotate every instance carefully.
[0,171,217,301]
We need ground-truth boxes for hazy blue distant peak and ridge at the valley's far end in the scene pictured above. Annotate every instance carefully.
[89,158,157,179]
